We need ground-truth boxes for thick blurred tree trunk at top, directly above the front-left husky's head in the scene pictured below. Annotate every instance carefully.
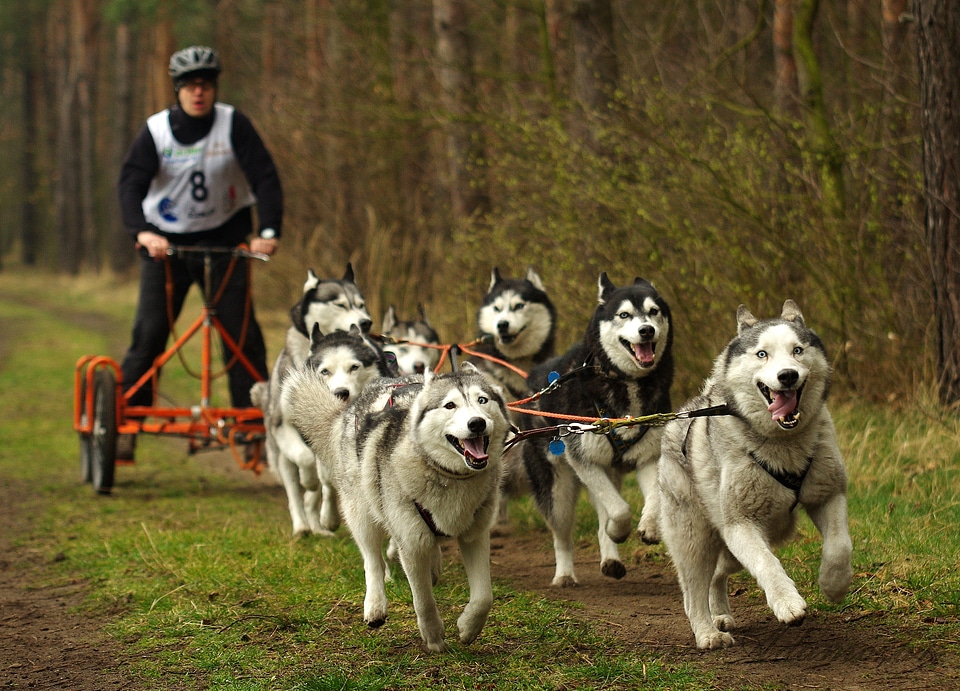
[433,0,490,218]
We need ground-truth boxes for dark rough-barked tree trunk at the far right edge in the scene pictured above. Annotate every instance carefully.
[912,0,960,406]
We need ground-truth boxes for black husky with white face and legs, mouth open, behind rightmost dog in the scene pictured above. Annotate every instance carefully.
[523,272,673,587]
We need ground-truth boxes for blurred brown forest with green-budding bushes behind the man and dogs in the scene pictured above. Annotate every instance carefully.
[0,0,937,403]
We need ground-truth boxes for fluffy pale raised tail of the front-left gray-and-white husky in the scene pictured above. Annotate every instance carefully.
[280,367,343,458]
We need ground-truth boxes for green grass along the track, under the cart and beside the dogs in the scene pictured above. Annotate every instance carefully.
[0,272,960,689]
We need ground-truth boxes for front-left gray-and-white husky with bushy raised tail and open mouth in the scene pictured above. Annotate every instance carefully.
[283,363,509,652]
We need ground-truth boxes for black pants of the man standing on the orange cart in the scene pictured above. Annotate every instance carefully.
[121,252,267,408]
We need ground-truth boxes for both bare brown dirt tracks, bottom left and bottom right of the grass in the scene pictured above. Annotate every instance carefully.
[0,474,960,691]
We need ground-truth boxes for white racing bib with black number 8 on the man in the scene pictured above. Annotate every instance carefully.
[143,103,257,233]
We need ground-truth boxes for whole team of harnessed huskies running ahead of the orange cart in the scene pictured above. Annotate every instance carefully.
[252,264,852,652]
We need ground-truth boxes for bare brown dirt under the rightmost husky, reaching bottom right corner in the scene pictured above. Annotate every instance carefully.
[492,535,960,691]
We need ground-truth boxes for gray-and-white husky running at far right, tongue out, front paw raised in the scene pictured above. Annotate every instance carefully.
[659,300,852,648]
